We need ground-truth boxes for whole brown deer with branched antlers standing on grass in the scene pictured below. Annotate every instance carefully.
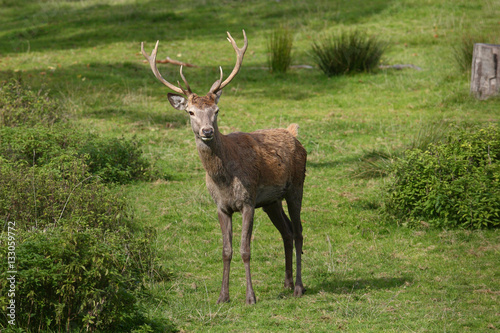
[141,30,307,304]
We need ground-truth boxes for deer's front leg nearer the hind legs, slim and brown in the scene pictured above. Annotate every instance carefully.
[240,206,257,304]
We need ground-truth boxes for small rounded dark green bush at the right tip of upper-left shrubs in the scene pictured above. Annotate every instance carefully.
[80,138,150,184]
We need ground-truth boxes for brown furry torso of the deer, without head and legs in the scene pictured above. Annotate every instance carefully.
[198,129,306,213]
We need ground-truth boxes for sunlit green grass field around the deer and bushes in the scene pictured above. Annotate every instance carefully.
[0,0,500,332]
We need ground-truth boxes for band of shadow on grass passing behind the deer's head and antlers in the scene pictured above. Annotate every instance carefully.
[0,57,340,115]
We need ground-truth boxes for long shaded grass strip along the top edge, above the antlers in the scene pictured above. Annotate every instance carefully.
[0,0,390,53]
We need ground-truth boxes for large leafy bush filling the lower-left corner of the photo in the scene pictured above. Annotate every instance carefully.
[0,158,171,332]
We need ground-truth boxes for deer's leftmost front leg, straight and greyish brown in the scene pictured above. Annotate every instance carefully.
[217,210,233,304]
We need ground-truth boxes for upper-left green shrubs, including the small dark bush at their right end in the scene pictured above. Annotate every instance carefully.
[0,80,151,184]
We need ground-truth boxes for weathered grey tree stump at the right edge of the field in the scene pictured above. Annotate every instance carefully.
[470,43,500,100]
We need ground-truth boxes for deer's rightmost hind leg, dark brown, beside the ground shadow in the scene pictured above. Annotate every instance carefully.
[285,186,305,297]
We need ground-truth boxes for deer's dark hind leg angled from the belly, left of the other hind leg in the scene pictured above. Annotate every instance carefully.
[262,201,293,289]
